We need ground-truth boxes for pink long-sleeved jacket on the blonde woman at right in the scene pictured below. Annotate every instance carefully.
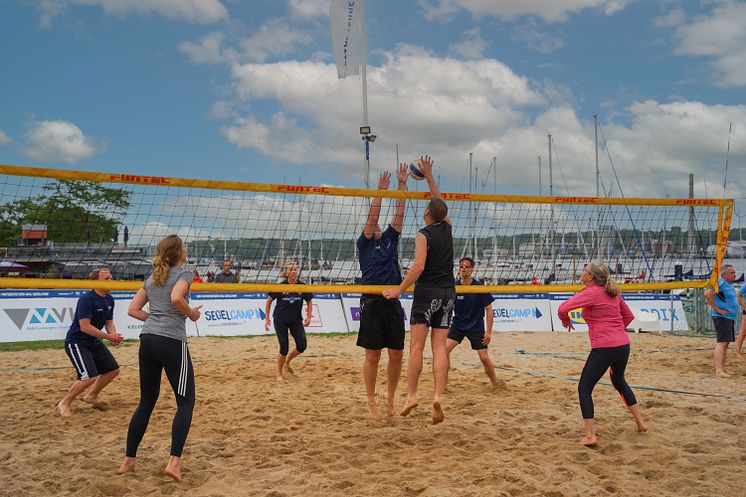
[557,285,635,349]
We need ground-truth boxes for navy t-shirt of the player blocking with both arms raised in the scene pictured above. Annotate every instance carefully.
[357,225,402,285]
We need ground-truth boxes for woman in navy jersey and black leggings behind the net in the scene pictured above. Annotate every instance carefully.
[264,262,313,381]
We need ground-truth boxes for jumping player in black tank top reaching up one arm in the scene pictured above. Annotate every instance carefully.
[383,156,456,424]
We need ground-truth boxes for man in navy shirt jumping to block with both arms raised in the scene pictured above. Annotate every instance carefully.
[357,164,407,421]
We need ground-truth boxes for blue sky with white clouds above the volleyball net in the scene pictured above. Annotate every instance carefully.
[0,0,746,227]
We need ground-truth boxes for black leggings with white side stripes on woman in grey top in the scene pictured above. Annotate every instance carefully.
[127,334,195,457]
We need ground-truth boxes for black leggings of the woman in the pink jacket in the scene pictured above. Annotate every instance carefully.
[578,344,637,419]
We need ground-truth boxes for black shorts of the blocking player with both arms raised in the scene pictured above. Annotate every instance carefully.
[357,295,404,350]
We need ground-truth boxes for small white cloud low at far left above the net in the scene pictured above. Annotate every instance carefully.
[24,121,103,164]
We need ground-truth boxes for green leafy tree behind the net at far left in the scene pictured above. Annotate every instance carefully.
[0,179,131,246]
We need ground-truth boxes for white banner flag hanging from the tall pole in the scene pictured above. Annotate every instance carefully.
[329,0,361,79]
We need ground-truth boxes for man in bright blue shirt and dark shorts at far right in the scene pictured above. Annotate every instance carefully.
[705,264,740,378]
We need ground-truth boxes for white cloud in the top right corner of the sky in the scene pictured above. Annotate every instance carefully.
[674,2,746,87]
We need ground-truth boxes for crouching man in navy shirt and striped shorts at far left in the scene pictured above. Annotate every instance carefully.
[57,268,124,416]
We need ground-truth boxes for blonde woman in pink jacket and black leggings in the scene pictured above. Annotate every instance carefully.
[557,260,648,447]
